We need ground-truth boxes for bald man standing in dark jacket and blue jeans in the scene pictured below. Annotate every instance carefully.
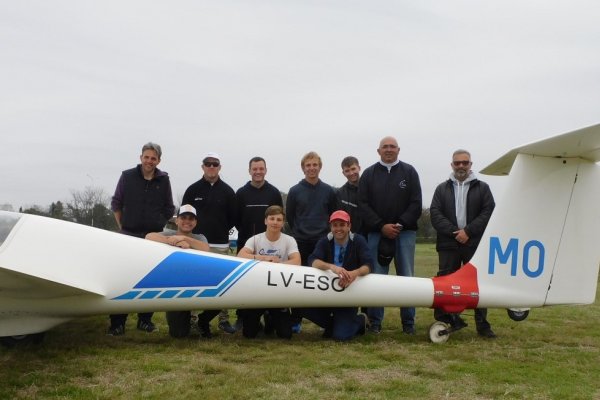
[358,136,423,335]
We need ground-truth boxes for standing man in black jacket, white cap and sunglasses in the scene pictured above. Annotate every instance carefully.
[182,152,236,336]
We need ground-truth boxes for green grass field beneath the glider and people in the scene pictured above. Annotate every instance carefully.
[0,245,600,400]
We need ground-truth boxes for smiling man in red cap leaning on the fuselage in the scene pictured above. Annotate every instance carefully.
[302,210,373,340]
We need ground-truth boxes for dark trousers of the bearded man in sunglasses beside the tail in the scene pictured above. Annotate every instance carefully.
[433,246,490,332]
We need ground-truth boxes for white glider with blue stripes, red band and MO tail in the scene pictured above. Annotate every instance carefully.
[0,125,600,337]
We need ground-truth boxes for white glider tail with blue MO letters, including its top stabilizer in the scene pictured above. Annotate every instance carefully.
[471,125,600,308]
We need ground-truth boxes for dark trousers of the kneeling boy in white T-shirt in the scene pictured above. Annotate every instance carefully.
[239,308,292,339]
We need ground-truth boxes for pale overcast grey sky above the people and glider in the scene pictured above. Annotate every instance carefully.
[0,0,600,210]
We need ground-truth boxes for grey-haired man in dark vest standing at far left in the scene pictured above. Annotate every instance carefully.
[108,142,175,336]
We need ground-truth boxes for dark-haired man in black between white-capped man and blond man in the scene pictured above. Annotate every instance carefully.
[235,157,283,253]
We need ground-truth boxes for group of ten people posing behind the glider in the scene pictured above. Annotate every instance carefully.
[109,136,496,340]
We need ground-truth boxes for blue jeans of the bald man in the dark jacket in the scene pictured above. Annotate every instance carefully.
[367,231,417,328]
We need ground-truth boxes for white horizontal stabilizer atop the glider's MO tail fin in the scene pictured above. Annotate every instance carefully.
[481,124,600,175]
